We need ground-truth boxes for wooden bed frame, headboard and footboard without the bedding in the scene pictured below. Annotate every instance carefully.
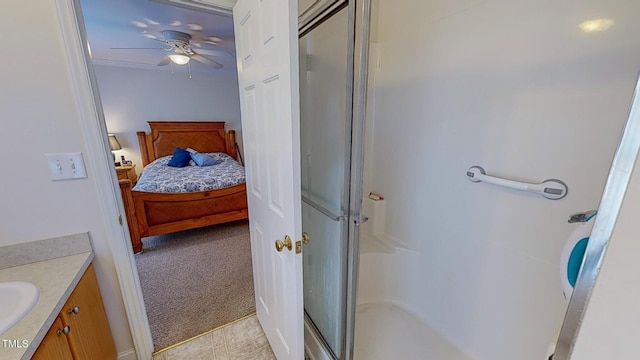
[120,121,248,253]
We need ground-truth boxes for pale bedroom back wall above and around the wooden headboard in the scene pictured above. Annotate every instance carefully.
[95,65,242,173]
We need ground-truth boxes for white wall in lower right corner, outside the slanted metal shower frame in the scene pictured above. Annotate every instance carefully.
[571,146,640,360]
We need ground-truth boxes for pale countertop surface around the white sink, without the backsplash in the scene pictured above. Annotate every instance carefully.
[0,251,93,360]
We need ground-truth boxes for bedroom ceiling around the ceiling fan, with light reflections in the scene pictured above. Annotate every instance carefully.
[80,0,236,72]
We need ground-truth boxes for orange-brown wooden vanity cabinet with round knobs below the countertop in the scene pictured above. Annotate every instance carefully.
[32,264,116,360]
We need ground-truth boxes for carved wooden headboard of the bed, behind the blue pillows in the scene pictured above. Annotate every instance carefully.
[136,121,237,166]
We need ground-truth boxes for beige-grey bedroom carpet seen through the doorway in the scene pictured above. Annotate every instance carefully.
[135,220,255,351]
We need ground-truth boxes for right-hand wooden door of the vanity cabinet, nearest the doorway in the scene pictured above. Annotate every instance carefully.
[60,264,116,359]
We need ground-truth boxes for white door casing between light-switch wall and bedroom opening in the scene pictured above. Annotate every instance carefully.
[55,0,153,359]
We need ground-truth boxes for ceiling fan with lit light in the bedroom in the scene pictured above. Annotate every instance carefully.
[111,30,225,69]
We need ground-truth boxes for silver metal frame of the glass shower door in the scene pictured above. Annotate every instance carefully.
[299,0,371,360]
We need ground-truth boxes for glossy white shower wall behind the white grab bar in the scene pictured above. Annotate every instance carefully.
[363,0,640,360]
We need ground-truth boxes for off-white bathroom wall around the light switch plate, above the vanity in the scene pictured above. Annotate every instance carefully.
[0,0,133,357]
